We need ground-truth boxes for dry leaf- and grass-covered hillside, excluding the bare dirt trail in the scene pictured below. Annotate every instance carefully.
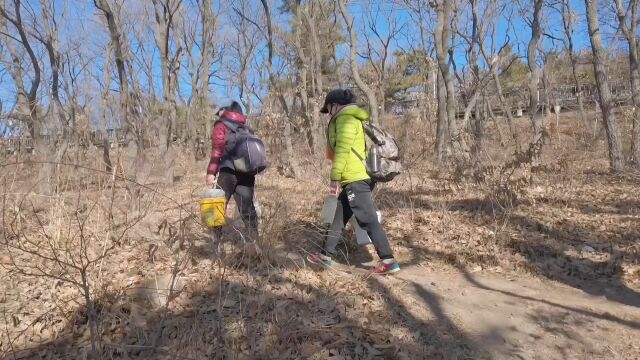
[0,111,640,359]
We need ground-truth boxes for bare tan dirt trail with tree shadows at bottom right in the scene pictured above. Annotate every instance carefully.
[390,267,640,359]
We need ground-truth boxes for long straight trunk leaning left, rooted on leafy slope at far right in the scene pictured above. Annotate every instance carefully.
[585,0,624,173]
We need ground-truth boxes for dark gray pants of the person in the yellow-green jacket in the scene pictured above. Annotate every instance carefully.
[322,180,393,259]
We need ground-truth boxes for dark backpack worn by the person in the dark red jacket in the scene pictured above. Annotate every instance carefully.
[220,119,267,175]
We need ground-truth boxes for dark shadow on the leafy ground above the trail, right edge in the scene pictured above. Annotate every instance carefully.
[449,195,640,307]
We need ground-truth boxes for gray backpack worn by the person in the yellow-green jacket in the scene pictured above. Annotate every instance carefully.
[351,122,402,182]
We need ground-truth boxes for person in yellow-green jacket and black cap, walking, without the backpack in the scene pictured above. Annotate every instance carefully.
[307,89,400,275]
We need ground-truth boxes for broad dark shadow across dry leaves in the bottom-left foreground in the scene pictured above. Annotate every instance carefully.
[3,249,488,359]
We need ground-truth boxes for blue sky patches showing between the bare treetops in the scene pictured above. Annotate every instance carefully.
[0,0,611,134]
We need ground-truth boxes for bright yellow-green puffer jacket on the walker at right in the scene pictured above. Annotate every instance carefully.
[327,105,369,186]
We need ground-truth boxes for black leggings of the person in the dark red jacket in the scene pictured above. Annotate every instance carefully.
[218,168,258,241]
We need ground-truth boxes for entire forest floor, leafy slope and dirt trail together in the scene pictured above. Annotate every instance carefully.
[0,112,640,360]
